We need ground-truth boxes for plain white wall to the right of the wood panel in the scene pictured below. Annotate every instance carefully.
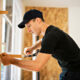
[68,7,80,47]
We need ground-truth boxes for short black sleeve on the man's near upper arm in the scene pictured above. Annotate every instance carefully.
[40,32,59,54]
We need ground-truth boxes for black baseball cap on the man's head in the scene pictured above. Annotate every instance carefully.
[18,9,43,28]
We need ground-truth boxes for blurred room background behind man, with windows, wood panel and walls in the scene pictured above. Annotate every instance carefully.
[0,0,80,80]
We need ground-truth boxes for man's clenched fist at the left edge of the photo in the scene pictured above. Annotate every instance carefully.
[1,53,13,66]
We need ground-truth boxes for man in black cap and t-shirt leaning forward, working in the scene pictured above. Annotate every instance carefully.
[1,9,80,80]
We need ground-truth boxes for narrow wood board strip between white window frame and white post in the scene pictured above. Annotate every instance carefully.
[21,28,32,80]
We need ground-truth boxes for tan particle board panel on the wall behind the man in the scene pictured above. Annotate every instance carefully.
[23,7,68,80]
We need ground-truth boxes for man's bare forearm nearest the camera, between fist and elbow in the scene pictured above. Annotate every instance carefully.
[11,59,39,71]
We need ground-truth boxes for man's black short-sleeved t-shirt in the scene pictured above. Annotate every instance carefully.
[40,25,80,71]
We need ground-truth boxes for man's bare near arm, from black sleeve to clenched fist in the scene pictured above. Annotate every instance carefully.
[1,53,51,71]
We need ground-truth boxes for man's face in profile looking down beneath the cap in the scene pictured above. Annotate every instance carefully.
[25,18,40,36]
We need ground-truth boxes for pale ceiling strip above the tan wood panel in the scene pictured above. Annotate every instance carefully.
[23,0,80,7]
